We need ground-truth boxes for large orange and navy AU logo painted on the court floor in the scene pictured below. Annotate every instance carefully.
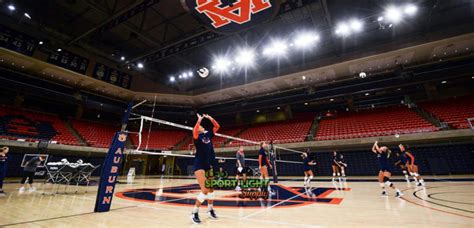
[116,184,350,208]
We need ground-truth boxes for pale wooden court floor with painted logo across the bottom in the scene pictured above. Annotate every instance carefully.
[0,176,474,228]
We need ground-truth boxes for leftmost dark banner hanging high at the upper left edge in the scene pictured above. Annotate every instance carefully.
[0,25,39,56]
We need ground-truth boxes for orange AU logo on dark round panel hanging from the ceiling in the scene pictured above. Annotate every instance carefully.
[182,0,280,33]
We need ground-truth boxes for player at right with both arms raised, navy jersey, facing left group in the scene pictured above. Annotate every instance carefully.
[372,141,403,197]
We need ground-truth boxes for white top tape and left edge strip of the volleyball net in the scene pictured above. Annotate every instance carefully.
[134,114,304,157]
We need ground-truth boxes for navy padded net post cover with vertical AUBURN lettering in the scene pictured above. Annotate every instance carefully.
[94,132,127,212]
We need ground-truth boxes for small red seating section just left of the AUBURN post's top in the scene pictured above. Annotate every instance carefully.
[71,120,120,148]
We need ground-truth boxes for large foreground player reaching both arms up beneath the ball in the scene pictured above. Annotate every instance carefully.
[191,114,220,224]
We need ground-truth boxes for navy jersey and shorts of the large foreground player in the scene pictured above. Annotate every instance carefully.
[194,131,217,168]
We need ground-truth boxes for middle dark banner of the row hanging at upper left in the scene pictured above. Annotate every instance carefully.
[47,50,89,74]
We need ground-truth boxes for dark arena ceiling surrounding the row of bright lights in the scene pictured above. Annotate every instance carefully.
[0,0,474,97]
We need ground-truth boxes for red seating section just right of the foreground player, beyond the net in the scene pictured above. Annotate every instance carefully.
[227,116,313,146]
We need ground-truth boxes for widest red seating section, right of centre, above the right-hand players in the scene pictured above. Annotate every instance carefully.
[315,106,437,140]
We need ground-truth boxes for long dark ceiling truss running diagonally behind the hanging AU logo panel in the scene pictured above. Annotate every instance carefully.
[131,0,319,66]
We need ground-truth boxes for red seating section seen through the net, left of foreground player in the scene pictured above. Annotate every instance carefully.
[130,130,189,150]
